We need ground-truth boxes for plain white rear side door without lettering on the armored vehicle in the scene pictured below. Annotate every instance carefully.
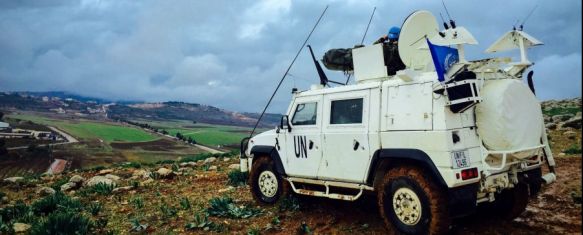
[318,90,370,183]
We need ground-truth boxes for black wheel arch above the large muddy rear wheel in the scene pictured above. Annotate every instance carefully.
[366,149,448,188]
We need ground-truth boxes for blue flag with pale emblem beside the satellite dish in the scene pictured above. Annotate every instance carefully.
[426,38,460,82]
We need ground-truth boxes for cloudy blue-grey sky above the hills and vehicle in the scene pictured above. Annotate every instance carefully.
[0,0,581,112]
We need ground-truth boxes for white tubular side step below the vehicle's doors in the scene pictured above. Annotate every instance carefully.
[286,177,374,201]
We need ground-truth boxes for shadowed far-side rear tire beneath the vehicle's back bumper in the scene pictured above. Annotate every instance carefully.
[493,183,528,220]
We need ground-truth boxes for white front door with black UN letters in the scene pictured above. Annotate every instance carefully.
[285,95,322,178]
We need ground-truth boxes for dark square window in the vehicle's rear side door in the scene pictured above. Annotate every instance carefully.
[330,98,363,124]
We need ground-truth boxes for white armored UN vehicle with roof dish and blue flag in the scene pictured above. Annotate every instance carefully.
[241,11,555,234]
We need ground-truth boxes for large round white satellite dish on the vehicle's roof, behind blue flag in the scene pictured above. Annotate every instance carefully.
[399,10,439,69]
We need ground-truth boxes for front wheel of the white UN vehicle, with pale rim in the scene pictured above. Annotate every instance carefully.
[248,157,287,204]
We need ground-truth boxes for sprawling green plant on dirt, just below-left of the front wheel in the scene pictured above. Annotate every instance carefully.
[207,197,262,219]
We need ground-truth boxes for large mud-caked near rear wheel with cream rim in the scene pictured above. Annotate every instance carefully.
[377,166,450,234]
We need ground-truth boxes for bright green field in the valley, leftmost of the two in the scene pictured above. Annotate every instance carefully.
[9,114,158,143]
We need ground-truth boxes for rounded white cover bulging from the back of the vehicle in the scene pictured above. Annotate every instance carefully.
[476,79,543,151]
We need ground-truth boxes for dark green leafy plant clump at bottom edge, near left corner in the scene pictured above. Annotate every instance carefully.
[30,212,93,235]
